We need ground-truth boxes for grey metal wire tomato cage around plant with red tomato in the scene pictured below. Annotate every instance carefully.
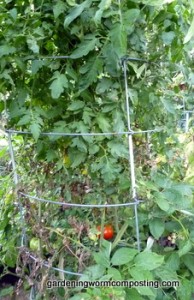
[5,56,158,282]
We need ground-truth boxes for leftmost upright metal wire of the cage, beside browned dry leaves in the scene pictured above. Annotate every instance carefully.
[8,133,26,247]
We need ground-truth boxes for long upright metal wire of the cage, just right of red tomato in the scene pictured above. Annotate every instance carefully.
[123,60,140,251]
